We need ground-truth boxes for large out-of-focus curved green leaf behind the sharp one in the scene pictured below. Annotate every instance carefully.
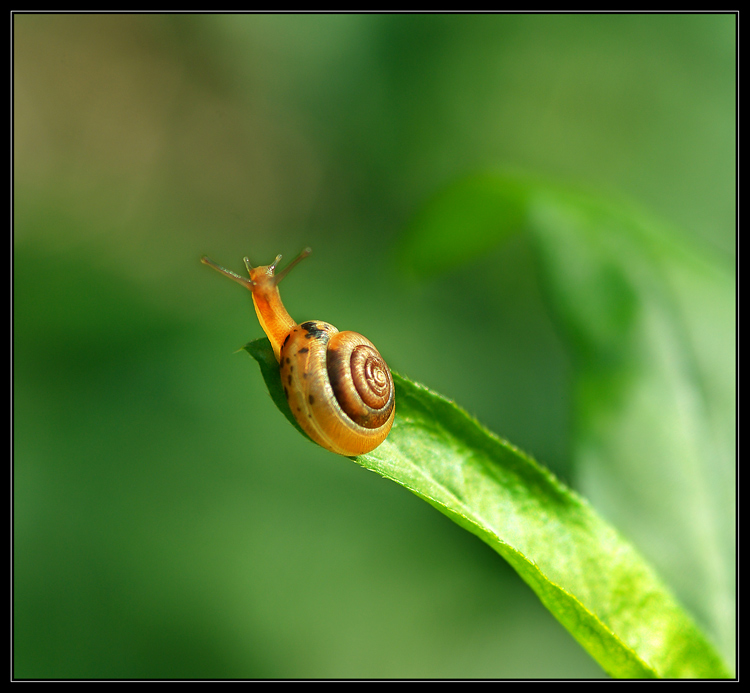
[403,174,737,676]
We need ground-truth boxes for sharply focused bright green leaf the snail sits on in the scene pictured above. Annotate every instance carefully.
[245,339,729,678]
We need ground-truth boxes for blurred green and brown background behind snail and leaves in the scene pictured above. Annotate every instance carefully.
[13,15,736,677]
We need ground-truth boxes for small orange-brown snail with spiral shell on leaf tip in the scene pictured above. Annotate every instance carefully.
[201,248,396,457]
